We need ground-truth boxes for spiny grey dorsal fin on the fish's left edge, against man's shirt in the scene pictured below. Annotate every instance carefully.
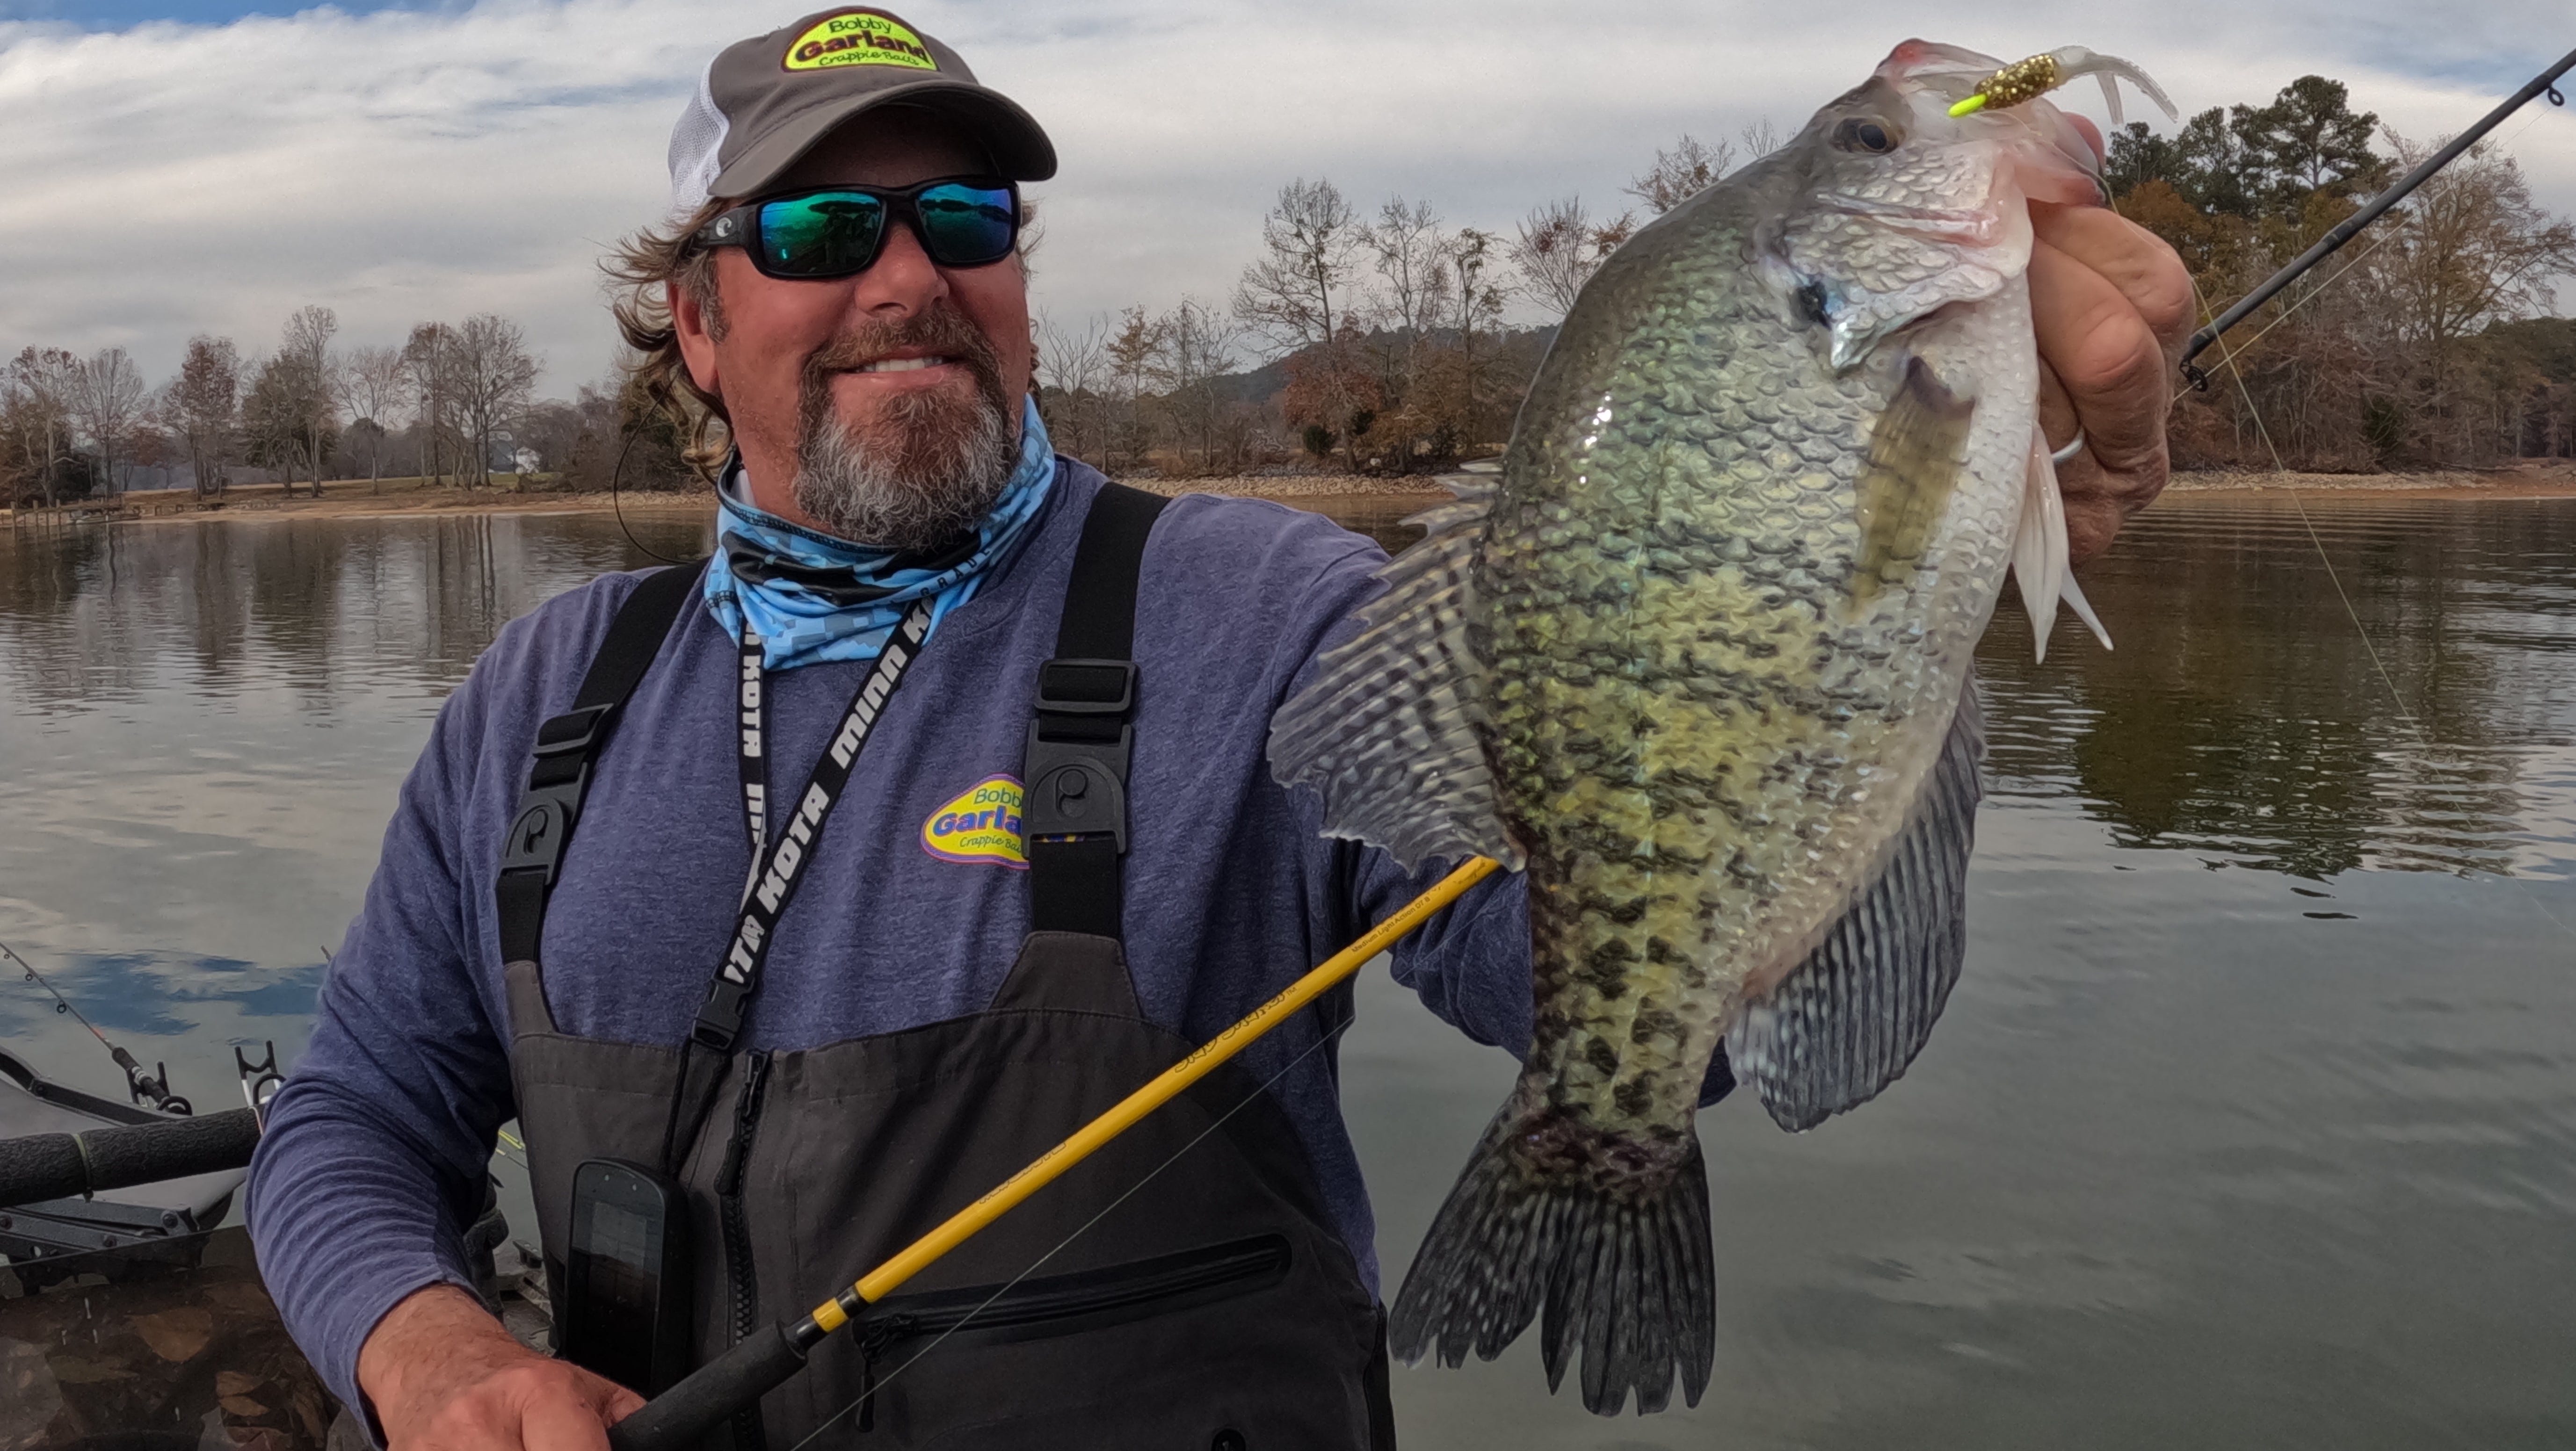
[1270,469,1523,871]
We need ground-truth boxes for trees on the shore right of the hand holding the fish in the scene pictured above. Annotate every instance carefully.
[2104,75,2576,472]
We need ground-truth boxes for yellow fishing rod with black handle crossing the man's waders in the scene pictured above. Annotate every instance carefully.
[608,856,1502,1451]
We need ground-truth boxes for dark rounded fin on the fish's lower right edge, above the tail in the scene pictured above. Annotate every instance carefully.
[1726,678,1986,1132]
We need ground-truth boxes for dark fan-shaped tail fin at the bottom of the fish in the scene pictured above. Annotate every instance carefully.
[1388,1100,1718,1415]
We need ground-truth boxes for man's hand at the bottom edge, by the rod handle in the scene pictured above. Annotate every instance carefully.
[358,1286,644,1451]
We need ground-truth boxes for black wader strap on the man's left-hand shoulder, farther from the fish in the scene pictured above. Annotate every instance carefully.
[492,564,701,964]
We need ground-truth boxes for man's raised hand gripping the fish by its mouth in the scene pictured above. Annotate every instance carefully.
[2030,201,2192,562]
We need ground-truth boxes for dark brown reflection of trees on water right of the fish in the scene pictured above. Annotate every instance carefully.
[1981,500,2576,879]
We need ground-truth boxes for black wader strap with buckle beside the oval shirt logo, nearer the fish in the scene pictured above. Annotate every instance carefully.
[1020,484,1169,938]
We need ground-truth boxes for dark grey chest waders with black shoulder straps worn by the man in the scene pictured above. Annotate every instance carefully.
[497,484,1393,1451]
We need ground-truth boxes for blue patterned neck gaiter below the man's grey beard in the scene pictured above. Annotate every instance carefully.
[706,399,1056,670]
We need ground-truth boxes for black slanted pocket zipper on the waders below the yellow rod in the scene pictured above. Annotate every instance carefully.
[858,1234,1288,1430]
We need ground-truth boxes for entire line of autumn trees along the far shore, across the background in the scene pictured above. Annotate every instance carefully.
[0,75,2576,503]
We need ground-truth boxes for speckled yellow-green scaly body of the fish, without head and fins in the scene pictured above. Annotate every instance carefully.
[1473,178,2032,1165]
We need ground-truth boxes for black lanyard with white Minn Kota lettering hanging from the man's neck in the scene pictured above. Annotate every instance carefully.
[688,598,930,1054]
